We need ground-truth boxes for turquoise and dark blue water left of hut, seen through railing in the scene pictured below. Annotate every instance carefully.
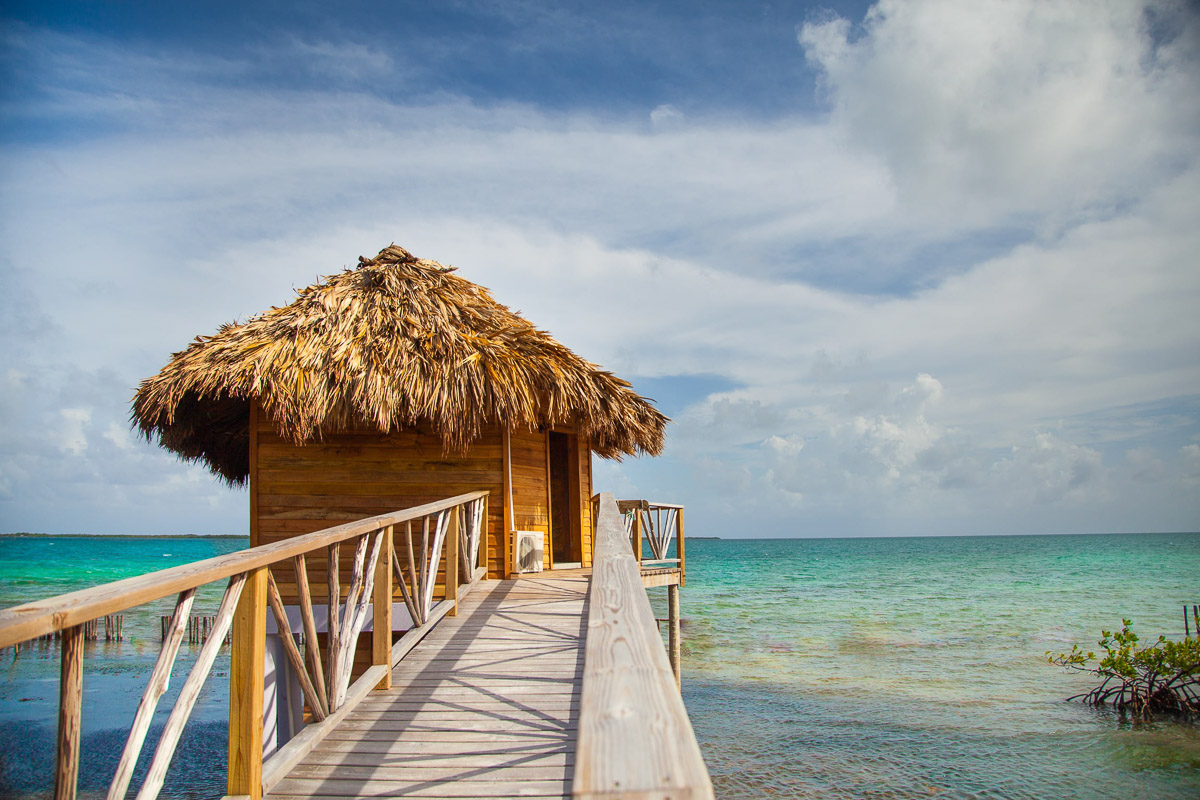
[0,536,248,799]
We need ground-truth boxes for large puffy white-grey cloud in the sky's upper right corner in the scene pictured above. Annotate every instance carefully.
[799,0,1200,235]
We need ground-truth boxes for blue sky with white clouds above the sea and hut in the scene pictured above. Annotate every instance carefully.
[0,0,1200,536]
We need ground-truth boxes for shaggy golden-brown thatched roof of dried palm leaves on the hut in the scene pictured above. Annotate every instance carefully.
[132,245,667,482]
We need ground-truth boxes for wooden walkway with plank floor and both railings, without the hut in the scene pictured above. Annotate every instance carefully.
[0,492,713,800]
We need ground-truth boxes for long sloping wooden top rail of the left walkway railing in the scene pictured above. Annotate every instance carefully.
[0,491,487,648]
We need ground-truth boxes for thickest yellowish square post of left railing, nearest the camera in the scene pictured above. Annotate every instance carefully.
[227,566,268,800]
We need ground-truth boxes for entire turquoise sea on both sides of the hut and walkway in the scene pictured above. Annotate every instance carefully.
[0,534,1200,799]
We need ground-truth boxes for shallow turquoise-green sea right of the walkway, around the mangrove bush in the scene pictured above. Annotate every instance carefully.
[655,534,1200,798]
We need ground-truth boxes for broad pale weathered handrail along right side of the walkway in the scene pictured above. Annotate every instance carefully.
[572,494,713,800]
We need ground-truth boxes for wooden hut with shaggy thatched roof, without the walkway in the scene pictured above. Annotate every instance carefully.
[133,245,667,587]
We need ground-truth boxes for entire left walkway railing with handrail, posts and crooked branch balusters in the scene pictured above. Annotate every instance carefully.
[0,492,487,800]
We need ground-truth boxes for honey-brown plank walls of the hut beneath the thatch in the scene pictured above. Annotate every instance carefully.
[250,405,594,585]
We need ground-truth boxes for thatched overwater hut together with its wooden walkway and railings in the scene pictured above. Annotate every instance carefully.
[0,245,713,800]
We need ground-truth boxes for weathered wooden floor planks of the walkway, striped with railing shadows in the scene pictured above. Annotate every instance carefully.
[268,571,588,800]
